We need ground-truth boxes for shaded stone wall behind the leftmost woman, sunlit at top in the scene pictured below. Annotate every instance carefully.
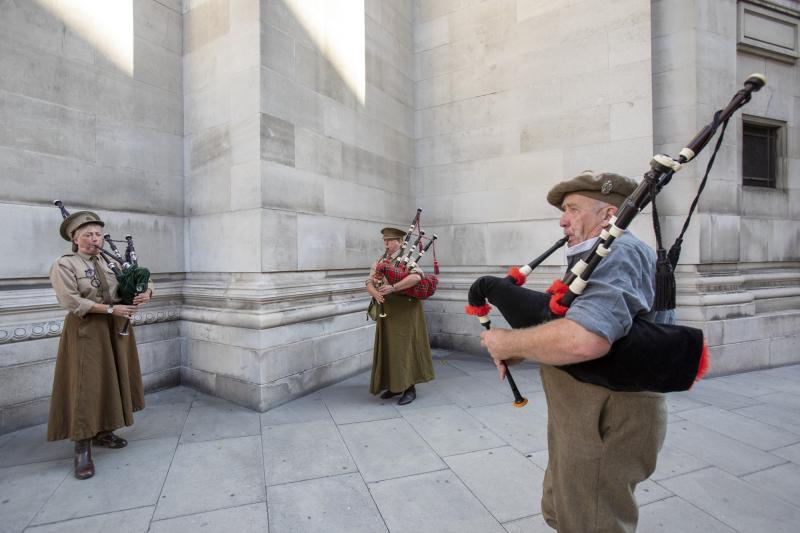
[0,0,185,433]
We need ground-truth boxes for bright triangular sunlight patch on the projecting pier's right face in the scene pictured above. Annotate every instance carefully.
[285,0,366,105]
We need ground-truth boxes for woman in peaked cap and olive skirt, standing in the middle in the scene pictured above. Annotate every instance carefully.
[366,228,434,405]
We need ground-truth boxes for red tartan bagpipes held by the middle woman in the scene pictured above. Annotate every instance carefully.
[373,208,439,318]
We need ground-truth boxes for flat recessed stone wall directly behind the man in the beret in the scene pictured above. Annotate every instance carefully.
[414,0,653,353]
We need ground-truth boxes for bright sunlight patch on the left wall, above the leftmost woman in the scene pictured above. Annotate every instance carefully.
[36,0,133,77]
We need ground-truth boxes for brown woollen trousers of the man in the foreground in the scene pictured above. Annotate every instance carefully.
[541,365,667,533]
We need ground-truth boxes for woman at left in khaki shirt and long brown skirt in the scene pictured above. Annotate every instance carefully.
[47,211,153,479]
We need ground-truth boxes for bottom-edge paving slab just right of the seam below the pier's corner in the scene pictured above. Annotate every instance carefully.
[267,474,387,533]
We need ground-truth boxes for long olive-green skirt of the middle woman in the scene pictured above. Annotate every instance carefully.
[369,294,435,394]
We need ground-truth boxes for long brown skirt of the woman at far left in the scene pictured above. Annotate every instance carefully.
[47,313,144,440]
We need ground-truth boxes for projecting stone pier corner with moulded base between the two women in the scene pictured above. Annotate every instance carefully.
[182,0,414,410]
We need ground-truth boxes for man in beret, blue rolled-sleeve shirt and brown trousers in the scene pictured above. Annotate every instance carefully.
[481,171,671,533]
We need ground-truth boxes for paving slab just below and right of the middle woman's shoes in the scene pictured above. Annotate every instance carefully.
[403,405,505,457]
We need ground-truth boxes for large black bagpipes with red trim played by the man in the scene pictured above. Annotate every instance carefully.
[465,74,766,407]
